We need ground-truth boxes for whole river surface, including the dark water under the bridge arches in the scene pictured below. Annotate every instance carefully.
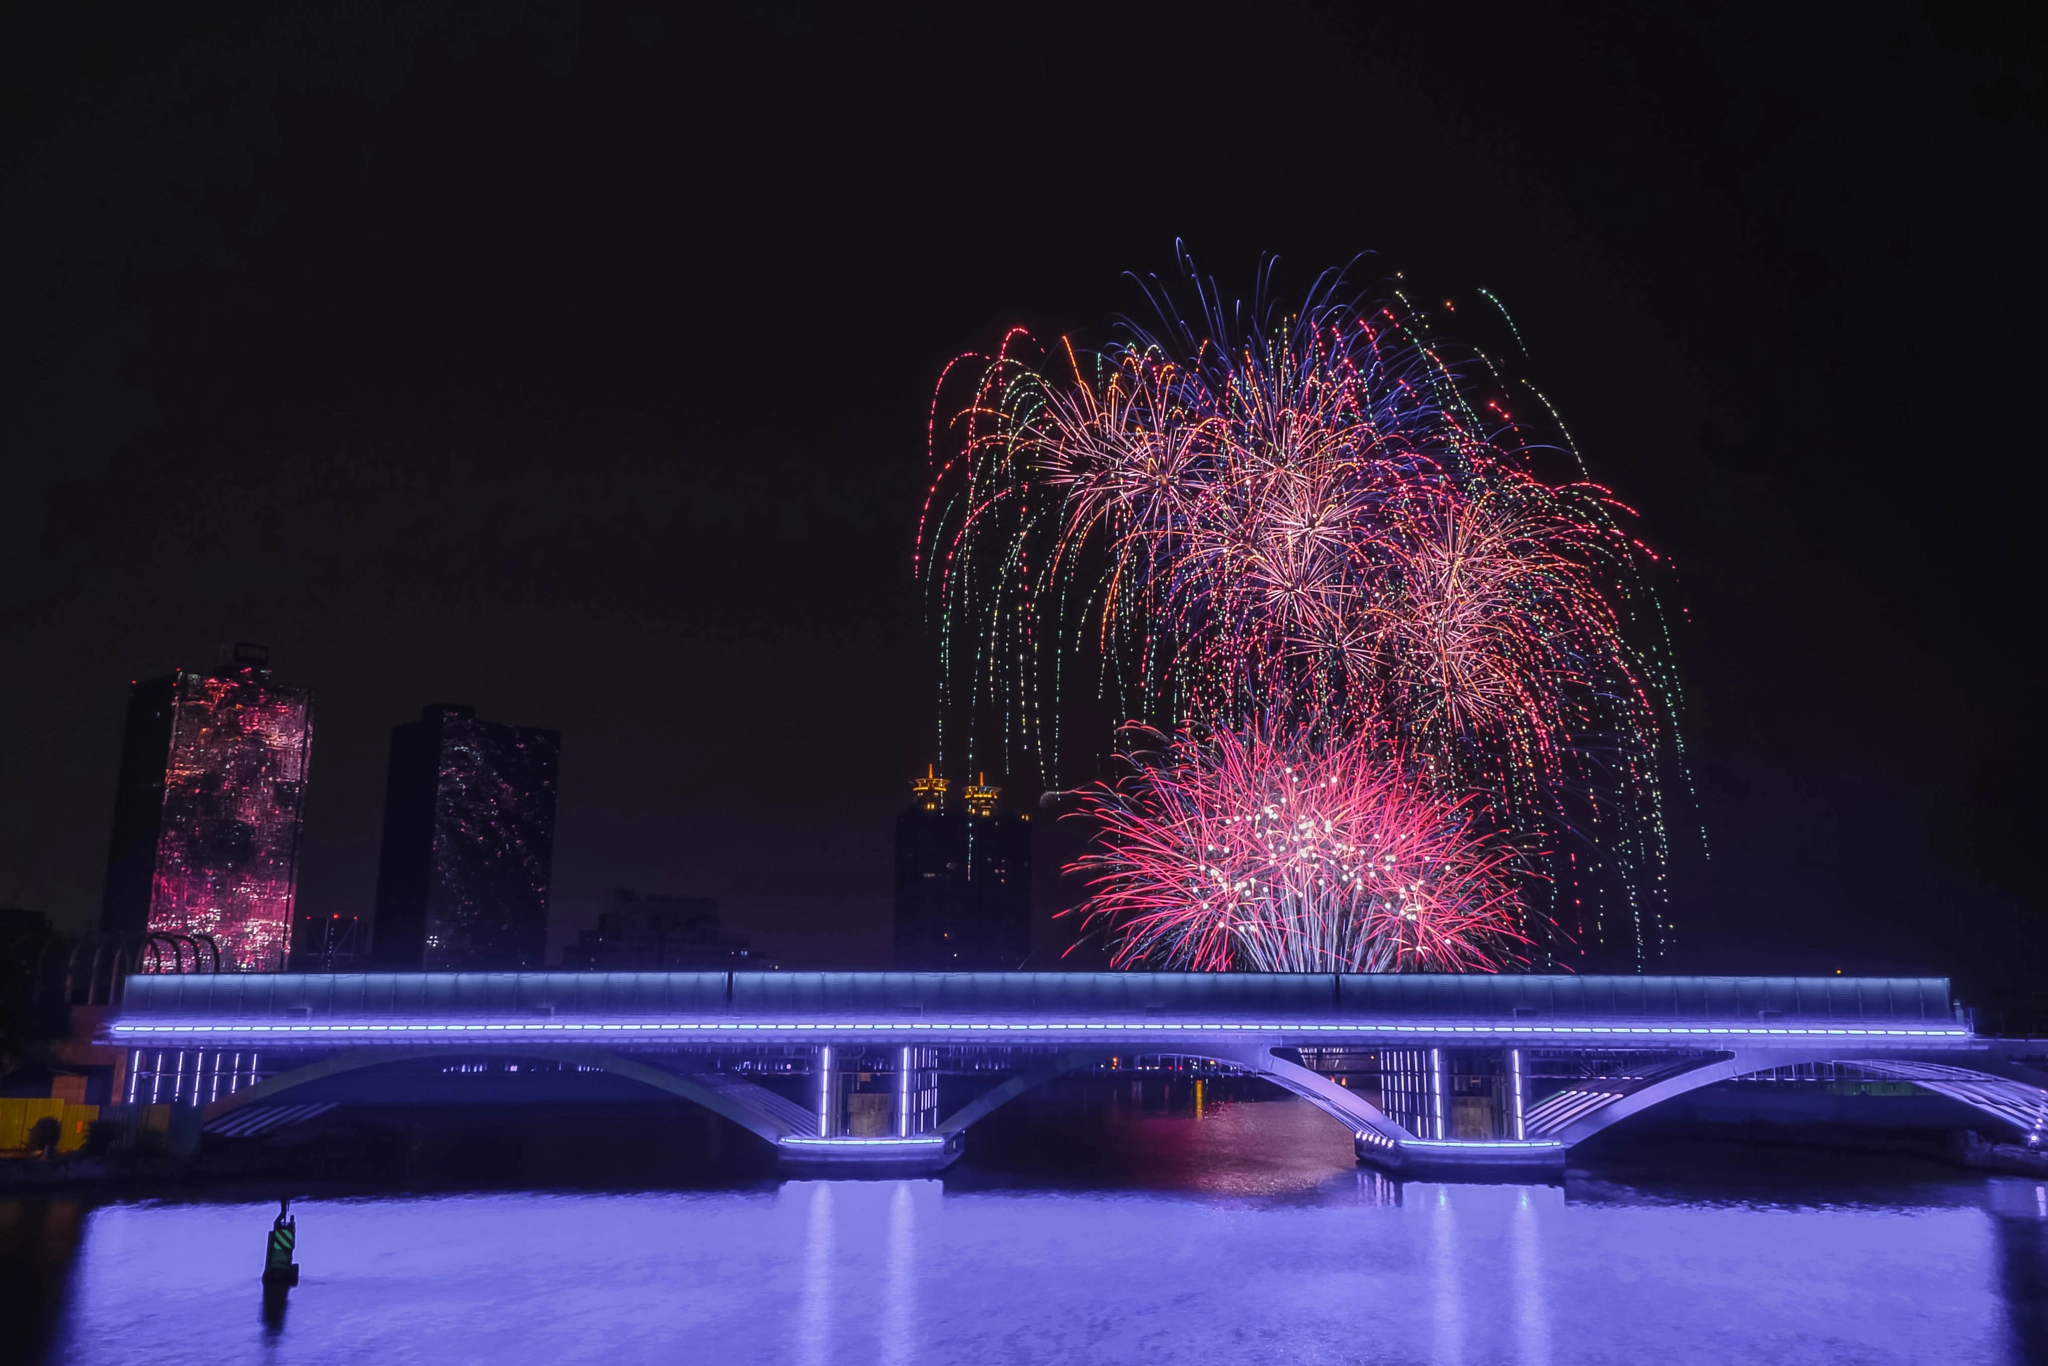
[0,1096,2048,1366]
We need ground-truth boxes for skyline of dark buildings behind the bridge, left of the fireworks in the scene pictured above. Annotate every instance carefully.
[81,655,1034,971]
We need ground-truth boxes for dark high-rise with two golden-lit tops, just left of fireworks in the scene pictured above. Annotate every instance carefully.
[895,766,1030,971]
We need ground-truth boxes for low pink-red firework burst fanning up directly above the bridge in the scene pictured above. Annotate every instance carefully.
[1071,725,1526,973]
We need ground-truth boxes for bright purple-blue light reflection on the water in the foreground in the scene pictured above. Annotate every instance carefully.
[44,1173,2015,1366]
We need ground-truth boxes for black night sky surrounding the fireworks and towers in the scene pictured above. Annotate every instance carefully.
[0,4,2048,1014]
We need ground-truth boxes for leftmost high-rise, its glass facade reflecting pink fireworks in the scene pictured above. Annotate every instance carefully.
[100,645,313,973]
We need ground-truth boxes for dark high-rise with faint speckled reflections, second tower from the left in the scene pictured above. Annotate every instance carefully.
[371,705,561,973]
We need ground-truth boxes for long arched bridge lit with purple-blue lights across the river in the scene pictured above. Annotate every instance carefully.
[106,973,2048,1171]
